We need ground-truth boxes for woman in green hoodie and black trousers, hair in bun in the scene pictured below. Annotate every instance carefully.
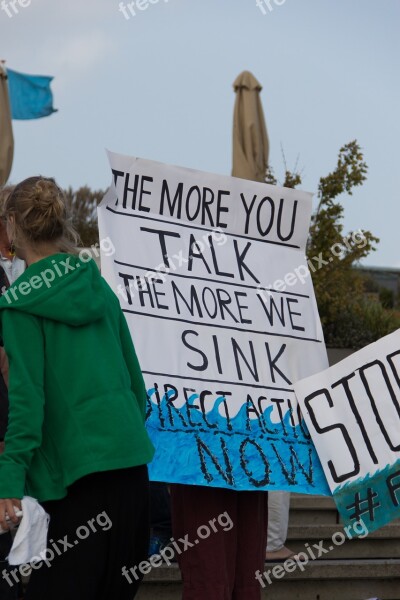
[0,177,154,600]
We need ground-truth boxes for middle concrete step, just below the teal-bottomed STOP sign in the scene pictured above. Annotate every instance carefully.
[287,522,400,560]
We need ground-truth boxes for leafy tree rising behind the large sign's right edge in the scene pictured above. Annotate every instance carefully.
[266,140,399,348]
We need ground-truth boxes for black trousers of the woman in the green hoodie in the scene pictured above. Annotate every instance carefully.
[25,465,149,600]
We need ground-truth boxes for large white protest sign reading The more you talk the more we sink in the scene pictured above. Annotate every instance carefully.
[99,153,329,494]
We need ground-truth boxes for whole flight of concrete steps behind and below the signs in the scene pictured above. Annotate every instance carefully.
[136,494,400,600]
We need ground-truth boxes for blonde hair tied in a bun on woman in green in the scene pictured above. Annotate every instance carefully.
[0,176,79,252]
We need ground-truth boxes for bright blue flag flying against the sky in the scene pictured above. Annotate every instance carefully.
[7,69,56,119]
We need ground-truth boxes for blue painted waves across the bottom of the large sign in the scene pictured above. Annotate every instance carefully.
[146,388,331,495]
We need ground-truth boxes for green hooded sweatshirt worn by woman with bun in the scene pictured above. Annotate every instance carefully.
[0,254,154,501]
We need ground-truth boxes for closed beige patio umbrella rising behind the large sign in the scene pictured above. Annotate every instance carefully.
[232,71,269,182]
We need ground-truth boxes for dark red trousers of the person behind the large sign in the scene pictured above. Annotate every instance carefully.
[171,484,268,600]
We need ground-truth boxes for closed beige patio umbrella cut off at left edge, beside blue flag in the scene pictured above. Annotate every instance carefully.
[0,61,14,186]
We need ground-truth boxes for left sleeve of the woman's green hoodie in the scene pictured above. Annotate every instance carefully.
[0,310,44,498]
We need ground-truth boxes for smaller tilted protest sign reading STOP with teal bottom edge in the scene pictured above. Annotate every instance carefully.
[294,330,400,532]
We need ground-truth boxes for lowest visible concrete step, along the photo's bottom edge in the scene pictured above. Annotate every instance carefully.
[136,559,400,600]
